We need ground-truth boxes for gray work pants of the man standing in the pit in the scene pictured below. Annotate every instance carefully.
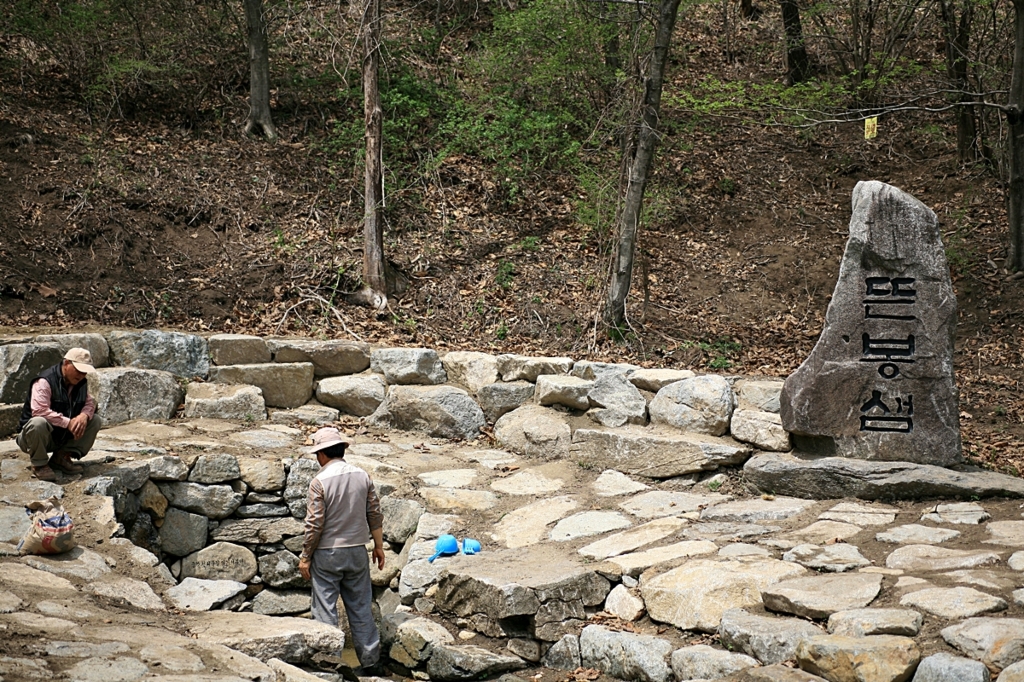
[309,545,381,666]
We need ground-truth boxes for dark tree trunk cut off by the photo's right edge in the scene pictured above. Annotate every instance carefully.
[1007,0,1024,270]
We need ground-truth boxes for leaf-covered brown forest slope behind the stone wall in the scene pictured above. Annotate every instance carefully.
[0,3,1024,474]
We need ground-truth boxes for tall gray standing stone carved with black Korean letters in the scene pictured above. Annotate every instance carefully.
[781,181,961,466]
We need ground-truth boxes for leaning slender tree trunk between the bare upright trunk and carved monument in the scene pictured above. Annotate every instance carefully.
[604,0,684,329]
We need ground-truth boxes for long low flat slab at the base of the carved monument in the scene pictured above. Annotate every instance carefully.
[743,453,1024,500]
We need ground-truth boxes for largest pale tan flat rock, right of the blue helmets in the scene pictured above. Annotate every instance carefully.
[640,558,806,632]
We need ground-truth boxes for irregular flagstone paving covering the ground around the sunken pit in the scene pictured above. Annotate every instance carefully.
[0,418,1024,682]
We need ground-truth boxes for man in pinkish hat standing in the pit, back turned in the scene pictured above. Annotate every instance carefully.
[299,427,384,675]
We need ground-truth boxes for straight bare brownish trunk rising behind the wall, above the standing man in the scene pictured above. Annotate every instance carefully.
[362,0,387,307]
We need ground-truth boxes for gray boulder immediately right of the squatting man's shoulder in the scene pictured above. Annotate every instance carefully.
[89,368,183,426]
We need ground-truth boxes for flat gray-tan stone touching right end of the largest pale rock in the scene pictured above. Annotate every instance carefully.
[761,573,882,619]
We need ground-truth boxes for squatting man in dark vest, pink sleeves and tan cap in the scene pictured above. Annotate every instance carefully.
[17,348,102,480]
